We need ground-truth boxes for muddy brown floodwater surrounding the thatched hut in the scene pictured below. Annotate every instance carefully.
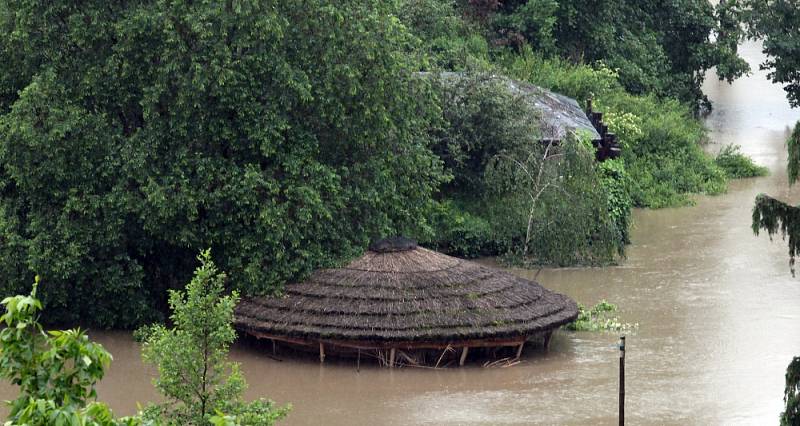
[0,39,800,425]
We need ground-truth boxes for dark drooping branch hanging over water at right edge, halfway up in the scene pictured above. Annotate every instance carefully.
[752,194,800,275]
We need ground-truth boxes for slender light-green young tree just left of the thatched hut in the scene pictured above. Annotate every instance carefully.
[140,250,288,425]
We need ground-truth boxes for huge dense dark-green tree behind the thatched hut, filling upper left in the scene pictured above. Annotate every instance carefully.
[0,0,443,326]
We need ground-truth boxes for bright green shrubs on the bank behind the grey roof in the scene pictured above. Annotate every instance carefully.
[504,51,727,208]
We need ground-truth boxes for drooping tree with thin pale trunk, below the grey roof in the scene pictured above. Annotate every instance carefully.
[487,138,624,266]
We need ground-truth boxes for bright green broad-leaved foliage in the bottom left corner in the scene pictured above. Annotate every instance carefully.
[0,276,139,426]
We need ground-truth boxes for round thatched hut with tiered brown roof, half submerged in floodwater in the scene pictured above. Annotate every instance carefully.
[235,239,578,366]
